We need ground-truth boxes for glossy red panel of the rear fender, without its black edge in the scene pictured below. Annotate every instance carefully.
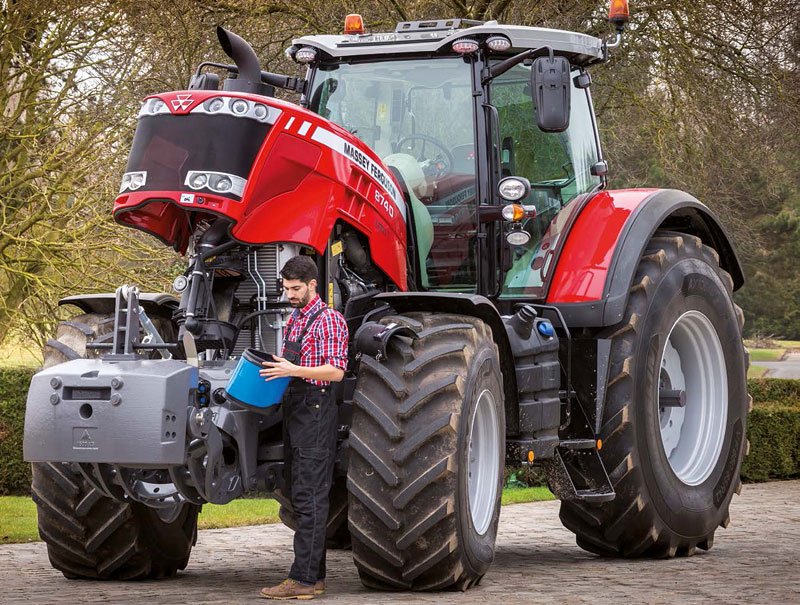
[547,189,657,304]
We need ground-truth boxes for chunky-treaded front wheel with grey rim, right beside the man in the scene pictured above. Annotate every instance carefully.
[347,313,505,590]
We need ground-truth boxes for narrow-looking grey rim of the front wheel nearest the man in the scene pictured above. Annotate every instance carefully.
[467,389,500,536]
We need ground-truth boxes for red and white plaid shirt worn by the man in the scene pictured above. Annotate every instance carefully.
[284,296,349,386]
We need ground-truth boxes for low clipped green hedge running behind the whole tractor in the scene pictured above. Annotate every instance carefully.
[0,368,800,495]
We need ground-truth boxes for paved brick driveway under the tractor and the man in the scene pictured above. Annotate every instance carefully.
[0,481,800,605]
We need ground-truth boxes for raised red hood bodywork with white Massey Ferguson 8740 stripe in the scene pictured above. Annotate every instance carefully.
[114,90,407,290]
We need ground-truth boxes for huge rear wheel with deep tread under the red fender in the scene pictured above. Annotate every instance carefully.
[560,232,748,557]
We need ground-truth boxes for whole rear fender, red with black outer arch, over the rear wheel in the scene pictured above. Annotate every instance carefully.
[547,189,744,327]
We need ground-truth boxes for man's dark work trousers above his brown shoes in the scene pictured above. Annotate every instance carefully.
[283,379,338,584]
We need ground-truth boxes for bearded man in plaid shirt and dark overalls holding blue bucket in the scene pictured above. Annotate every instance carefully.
[260,256,348,600]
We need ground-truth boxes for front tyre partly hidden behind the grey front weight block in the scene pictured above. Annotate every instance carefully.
[31,314,200,580]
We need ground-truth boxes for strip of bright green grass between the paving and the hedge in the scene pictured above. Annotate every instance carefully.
[0,487,553,544]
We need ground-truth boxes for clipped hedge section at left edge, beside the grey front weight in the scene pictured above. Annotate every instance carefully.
[0,368,34,495]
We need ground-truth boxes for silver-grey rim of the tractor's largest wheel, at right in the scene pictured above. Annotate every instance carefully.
[656,311,728,485]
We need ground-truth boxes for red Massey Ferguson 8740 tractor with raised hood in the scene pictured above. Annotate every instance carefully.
[25,4,748,590]
